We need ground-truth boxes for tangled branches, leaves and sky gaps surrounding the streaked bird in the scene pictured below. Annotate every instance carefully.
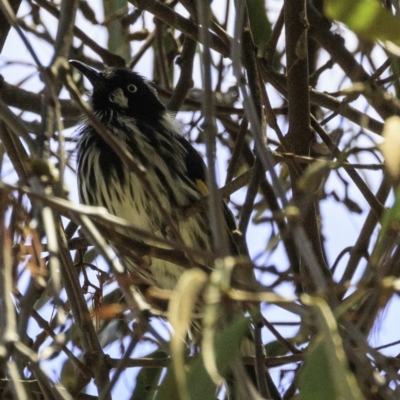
[0,0,400,399]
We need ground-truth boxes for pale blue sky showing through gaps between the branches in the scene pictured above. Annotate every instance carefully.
[0,1,400,400]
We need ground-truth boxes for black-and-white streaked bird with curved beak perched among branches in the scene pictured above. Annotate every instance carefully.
[69,60,277,398]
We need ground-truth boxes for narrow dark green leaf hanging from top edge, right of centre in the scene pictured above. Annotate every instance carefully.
[246,0,272,57]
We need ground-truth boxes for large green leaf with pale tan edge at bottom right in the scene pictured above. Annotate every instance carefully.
[299,295,364,400]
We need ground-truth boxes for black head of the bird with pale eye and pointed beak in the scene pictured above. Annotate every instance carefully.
[69,60,165,121]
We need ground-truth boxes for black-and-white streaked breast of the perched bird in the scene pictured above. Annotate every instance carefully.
[78,123,201,231]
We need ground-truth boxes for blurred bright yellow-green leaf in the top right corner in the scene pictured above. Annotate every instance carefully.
[324,0,400,45]
